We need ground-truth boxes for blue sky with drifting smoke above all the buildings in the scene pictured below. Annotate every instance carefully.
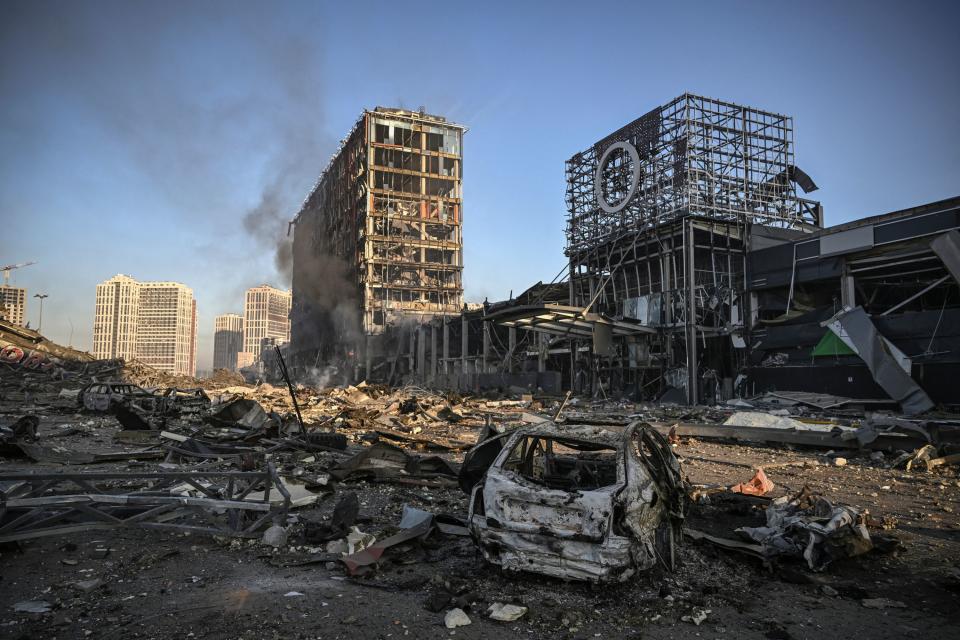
[0,1,960,368]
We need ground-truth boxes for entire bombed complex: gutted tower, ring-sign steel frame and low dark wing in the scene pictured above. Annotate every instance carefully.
[292,94,960,412]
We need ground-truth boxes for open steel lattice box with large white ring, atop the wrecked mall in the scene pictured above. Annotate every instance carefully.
[566,94,821,256]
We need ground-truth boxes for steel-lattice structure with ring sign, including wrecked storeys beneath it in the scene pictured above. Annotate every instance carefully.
[566,94,822,403]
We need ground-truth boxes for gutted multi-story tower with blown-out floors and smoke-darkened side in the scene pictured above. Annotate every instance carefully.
[291,107,465,372]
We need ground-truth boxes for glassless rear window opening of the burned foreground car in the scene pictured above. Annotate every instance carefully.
[503,436,617,491]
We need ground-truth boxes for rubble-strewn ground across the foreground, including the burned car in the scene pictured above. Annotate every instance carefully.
[0,330,960,637]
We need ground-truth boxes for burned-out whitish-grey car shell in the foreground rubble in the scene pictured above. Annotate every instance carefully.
[460,422,686,582]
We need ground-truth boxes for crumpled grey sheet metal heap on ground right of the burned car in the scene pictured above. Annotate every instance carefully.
[737,488,873,571]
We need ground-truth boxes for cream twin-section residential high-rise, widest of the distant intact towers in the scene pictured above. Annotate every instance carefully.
[93,275,197,376]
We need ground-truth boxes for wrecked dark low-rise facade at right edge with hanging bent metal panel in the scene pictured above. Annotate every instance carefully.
[744,197,960,413]
